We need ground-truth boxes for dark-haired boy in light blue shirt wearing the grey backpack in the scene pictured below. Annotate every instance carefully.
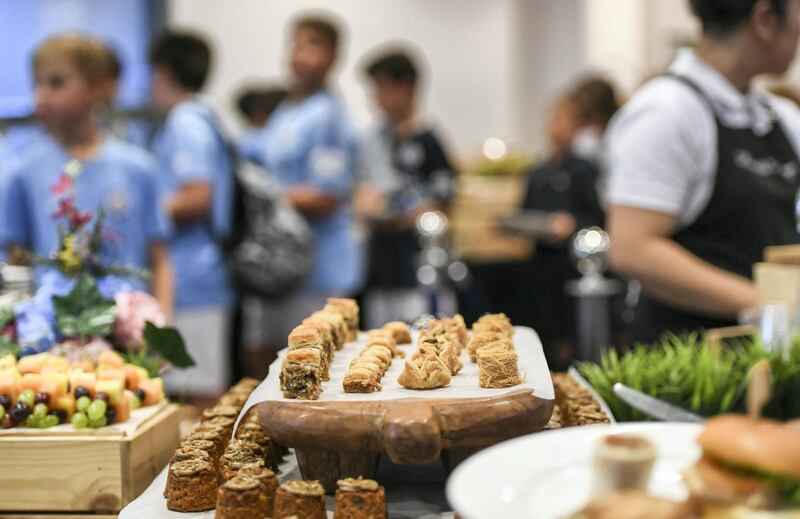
[150,33,233,396]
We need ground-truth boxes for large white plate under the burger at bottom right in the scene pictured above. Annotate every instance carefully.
[447,423,703,519]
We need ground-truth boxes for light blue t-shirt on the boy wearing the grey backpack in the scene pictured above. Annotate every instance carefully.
[153,98,233,308]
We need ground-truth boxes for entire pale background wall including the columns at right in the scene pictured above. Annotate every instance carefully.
[162,0,736,157]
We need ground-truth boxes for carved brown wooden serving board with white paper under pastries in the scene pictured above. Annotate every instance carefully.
[256,330,555,489]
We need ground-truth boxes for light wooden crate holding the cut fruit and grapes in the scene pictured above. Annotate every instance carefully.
[0,405,179,518]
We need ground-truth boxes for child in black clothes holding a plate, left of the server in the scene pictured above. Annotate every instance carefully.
[521,78,616,370]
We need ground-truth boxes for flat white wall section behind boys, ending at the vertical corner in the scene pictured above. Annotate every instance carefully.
[167,0,519,158]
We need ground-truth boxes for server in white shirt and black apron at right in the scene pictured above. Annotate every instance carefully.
[607,0,800,343]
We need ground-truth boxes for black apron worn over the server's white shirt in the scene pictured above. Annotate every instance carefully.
[632,76,800,343]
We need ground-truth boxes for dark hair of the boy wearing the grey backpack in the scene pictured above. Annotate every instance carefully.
[150,32,211,92]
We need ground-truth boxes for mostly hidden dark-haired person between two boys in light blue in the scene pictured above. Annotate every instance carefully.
[236,86,289,163]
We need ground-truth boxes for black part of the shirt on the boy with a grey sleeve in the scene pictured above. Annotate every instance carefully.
[367,125,456,289]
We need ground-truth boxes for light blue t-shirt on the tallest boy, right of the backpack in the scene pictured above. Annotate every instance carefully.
[261,91,362,295]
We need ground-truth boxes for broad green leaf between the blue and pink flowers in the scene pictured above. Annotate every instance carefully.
[53,275,115,339]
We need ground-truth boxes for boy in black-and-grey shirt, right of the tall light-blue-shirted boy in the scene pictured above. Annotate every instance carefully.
[356,46,456,328]
